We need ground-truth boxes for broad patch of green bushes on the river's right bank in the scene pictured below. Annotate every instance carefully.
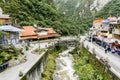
[71,48,112,80]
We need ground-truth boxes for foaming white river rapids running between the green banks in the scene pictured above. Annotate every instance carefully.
[53,47,79,80]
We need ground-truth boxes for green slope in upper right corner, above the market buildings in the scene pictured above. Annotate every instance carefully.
[96,0,120,18]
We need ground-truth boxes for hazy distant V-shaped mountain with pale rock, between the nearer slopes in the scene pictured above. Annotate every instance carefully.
[53,0,110,32]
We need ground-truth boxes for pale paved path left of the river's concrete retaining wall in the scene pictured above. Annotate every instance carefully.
[0,43,48,80]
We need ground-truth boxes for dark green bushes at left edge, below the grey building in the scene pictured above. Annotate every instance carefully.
[0,45,23,64]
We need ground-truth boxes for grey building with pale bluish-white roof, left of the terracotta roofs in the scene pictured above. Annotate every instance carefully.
[0,25,22,45]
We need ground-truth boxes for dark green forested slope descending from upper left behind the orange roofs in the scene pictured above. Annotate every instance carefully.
[0,0,91,35]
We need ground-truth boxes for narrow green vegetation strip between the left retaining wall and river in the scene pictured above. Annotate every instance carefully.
[41,46,66,80]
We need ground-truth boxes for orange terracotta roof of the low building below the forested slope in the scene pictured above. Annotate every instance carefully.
[20,26,59,40]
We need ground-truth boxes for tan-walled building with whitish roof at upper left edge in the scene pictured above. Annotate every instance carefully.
[0,8,11,25]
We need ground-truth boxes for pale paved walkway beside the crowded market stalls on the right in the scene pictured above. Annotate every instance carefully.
[84,37,120,78]
